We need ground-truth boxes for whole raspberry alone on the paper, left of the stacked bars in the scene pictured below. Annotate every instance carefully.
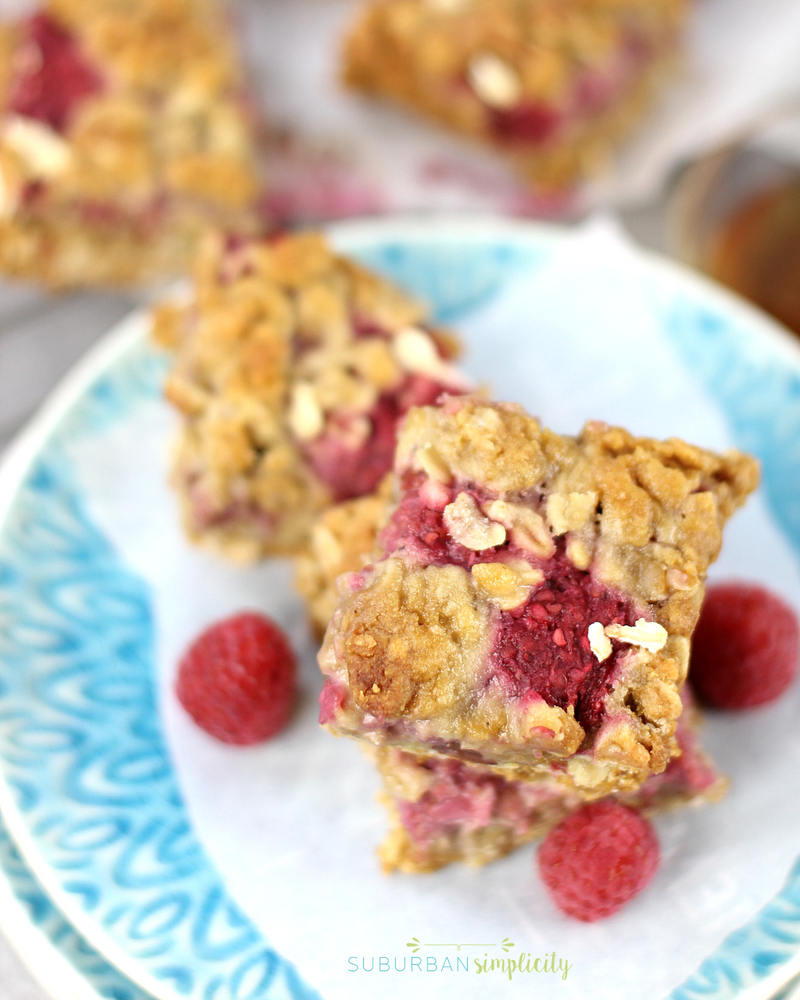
[175,611,297,745]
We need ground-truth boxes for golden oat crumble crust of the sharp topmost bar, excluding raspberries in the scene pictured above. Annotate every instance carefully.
[320,397,758,794]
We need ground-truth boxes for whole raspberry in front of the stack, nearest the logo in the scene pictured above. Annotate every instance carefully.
[538,799,660,923]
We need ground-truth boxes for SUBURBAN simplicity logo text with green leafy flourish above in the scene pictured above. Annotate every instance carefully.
[347,937,572,979]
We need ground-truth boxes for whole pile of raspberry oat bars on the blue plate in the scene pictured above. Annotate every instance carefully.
[155,242,758,871]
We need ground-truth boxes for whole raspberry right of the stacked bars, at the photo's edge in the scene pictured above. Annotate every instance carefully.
[689,583,800,708]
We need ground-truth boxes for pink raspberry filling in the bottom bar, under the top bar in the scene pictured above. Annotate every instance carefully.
[395,754,558,844]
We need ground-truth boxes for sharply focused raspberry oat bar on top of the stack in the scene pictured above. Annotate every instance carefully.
[319,397,758,794]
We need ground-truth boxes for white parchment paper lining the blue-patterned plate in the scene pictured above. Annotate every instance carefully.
[67,231,800,1000]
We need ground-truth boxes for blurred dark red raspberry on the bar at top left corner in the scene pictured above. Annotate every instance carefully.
[8,14,103,132]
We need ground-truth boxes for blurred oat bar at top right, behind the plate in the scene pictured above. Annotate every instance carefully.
[344,0,687,187]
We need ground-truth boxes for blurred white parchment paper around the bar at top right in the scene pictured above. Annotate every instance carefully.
[238,0,800,218]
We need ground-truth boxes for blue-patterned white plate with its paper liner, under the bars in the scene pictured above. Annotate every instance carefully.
[0,221,800,1000]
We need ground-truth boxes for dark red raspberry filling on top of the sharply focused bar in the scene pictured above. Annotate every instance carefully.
[381,472,641,730]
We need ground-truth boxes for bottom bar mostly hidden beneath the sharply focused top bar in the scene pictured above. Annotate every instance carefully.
[376,688,727,872]
